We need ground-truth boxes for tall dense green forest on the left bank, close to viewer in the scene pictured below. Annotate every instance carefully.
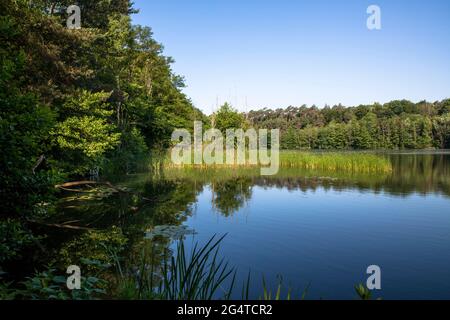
[0,0,206,271]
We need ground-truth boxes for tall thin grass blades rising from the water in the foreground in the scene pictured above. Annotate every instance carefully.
[115,235,316,301]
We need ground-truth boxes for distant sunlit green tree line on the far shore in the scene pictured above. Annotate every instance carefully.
[244,99,450,150]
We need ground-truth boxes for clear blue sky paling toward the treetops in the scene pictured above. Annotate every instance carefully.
[133,0,450,114]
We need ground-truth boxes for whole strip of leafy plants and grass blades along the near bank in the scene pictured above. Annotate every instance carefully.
[0,235,382,301]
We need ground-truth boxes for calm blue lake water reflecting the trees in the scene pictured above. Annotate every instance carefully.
[56,152,450,299]
